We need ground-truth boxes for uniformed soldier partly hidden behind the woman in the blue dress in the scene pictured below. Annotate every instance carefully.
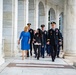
[27,23,34,57]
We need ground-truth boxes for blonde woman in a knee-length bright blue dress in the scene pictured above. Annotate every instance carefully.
[18,26,30,60]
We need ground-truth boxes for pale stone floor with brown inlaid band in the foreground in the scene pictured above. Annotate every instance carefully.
[0,56,76,75]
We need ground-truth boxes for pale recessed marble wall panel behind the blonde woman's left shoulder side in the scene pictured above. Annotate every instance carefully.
[18,0,25,38]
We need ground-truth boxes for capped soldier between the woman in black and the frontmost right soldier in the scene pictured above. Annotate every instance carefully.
[41,24,47,58]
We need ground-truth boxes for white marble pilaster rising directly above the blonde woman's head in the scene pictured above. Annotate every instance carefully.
[24,0,29,26]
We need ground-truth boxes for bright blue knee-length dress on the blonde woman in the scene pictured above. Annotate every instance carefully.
[20,31,30,50]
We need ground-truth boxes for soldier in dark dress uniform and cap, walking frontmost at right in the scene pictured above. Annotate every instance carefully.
[48,22,61,62]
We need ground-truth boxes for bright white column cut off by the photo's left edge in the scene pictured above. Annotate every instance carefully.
[0,0,4,65]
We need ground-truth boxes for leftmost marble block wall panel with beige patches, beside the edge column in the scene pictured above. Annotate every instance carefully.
[3,0,12,56]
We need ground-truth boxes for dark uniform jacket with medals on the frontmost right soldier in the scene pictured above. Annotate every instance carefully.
[48,28,61,45]
